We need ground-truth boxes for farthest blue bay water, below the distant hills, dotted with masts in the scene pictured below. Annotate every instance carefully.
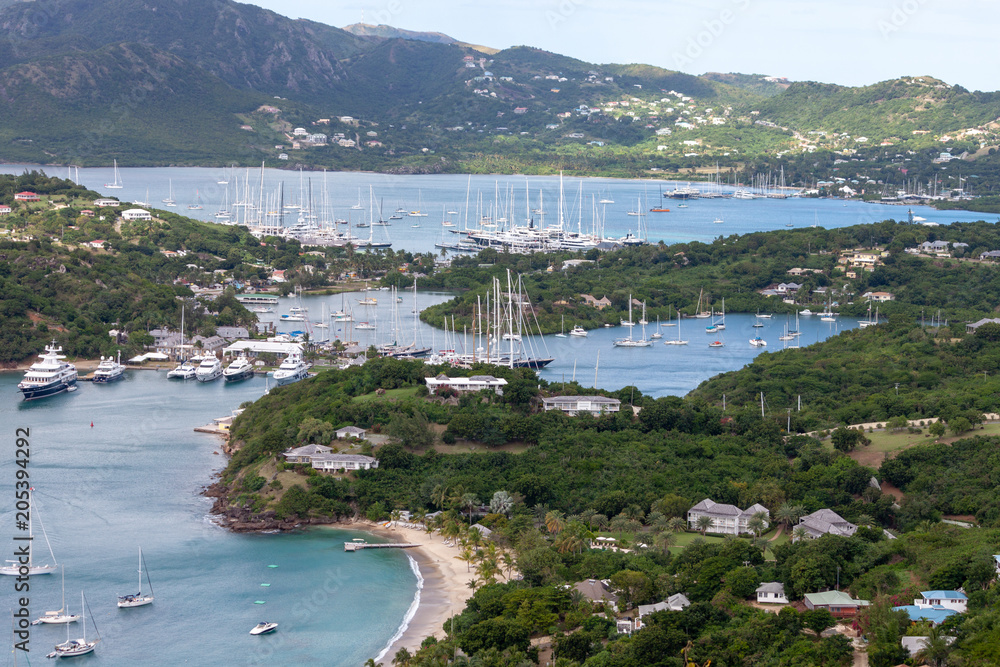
[0,164,997,252]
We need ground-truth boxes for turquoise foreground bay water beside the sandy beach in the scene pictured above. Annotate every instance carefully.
[0,371,416,665]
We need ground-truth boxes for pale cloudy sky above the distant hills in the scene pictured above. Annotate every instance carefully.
[243,0,1000,91]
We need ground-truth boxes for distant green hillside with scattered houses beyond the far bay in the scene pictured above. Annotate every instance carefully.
[0,0,1000,185]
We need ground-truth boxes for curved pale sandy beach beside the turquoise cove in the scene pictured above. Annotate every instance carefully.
[362,522,475,665]
